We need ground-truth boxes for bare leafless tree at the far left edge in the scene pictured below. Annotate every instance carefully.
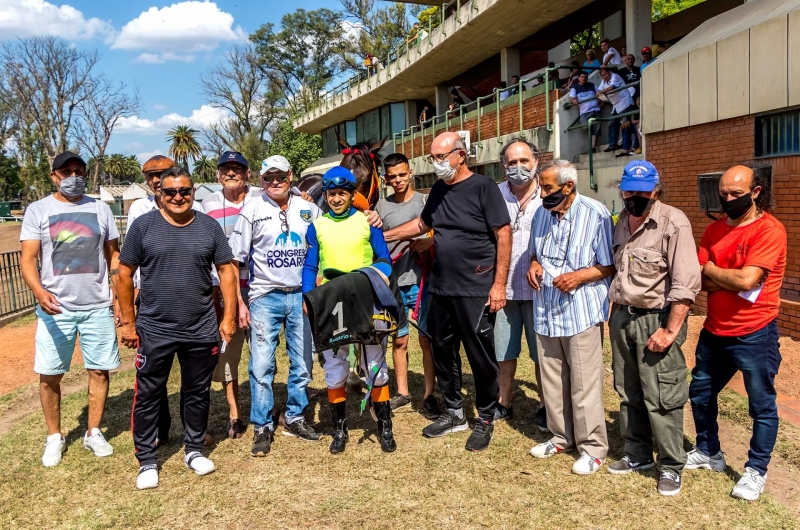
[0,36,99,162]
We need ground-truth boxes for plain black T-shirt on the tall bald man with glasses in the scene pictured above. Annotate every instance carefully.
[421,174,511,296]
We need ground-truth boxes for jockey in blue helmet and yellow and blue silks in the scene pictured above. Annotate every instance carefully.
[303,166,397,454]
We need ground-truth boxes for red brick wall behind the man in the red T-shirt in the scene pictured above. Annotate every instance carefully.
[646,116,800,339]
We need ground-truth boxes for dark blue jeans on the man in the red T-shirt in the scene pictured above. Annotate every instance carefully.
[689,320,781,475]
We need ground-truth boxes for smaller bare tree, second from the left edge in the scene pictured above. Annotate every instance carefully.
[75,76,141,191]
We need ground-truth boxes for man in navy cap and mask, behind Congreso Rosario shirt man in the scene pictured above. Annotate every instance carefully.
[203,151,262,438]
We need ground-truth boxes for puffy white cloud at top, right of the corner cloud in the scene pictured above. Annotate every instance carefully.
[111,0,247,64]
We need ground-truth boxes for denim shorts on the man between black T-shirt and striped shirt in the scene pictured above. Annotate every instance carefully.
[494,300,539,363]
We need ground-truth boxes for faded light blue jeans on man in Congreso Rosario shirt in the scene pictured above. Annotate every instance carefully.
[249,289,312,430]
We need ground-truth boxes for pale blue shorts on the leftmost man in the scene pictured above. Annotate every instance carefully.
[33,305,119,375]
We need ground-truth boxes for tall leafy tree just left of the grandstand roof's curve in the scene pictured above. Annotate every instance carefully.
[250,9,344,112]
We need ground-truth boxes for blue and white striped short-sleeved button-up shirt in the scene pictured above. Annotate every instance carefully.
[530,191,614,337]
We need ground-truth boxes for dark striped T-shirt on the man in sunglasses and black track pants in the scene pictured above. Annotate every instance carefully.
[119,210,233,342]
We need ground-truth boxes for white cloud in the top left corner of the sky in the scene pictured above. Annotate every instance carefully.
[0,0,114,41]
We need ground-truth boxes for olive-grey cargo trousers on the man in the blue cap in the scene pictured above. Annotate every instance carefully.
[608,306,689,474]
